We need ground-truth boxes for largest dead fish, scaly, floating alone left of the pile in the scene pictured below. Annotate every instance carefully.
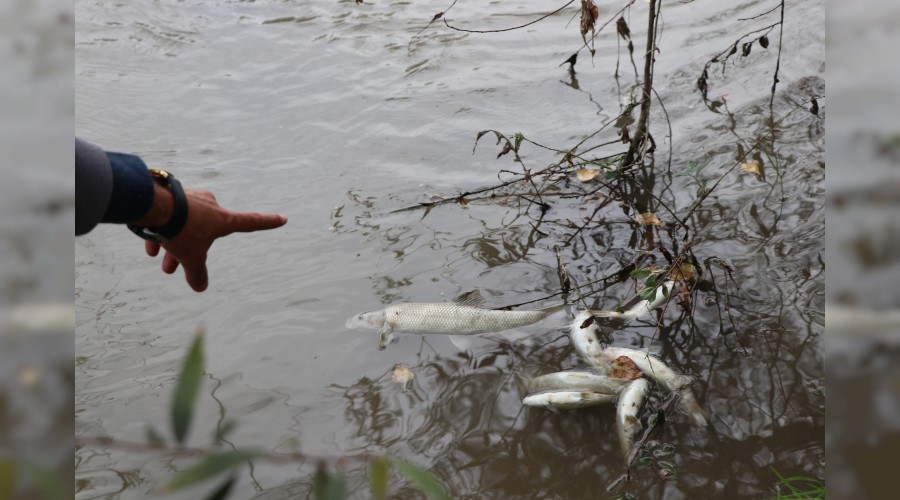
[346,290,565,350]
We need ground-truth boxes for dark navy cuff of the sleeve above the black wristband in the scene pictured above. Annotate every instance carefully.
[103,152,153,224]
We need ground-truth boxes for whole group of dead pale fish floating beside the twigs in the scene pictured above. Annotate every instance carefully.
[346,281,707,457]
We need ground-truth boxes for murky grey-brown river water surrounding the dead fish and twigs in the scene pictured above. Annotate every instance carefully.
[75,1,824,498]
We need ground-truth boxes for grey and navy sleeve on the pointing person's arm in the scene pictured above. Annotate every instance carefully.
[75,138,153,235]
